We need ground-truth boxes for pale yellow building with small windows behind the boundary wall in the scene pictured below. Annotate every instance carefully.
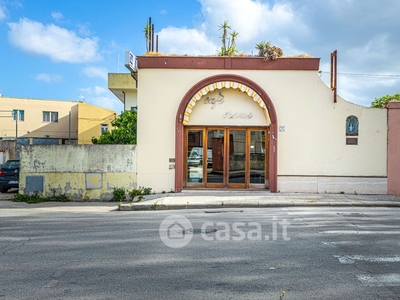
[0,97,117,150]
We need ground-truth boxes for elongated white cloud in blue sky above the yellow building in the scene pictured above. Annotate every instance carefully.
[8,18,101,63]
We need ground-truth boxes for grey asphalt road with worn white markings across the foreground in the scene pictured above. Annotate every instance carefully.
[0,201,400,300]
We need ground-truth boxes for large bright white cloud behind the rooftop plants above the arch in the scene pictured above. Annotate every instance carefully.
[159,0,311,55]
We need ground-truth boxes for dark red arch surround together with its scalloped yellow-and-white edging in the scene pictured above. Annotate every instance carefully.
[175,74,278,192]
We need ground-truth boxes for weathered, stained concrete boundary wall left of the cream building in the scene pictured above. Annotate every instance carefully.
[19,145,137,201]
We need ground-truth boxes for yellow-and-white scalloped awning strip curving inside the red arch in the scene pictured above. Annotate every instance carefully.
[182,81,271,126]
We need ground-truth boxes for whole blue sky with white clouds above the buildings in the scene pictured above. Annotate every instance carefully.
[0,0,400,112]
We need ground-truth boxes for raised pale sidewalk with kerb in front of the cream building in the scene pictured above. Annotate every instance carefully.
[120,190,400,211]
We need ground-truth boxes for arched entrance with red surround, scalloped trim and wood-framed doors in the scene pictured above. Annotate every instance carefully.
[175,74,277,192]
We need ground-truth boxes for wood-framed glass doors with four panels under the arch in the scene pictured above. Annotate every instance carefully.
[185,127,268,188]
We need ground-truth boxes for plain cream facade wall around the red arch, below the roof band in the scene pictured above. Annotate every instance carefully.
[137,69,387,193]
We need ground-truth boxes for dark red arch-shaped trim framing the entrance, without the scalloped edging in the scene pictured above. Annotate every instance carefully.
[175,74,278,192]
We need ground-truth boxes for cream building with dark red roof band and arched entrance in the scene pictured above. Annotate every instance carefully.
[109,56,400,194]
